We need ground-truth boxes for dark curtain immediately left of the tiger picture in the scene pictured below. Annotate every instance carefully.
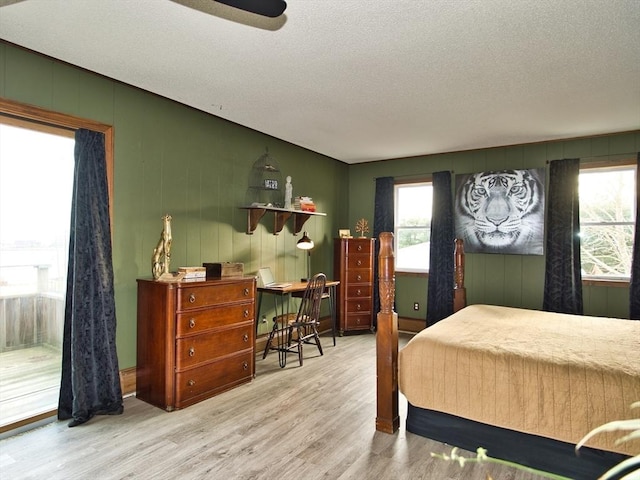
[427,172,455,325]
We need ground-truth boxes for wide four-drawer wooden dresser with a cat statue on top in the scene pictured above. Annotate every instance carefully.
[136,277,256,411]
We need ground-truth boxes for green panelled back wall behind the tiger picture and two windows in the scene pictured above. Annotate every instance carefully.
[350,131,640,319]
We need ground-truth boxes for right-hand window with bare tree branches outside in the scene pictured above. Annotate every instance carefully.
[579,165,636,280]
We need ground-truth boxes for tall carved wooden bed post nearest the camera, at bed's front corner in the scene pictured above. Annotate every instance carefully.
[376,232,400,433]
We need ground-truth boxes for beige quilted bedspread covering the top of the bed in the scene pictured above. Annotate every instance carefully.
[398,305,640,454]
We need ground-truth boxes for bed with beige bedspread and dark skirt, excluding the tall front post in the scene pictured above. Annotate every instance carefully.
[379,234,640,479]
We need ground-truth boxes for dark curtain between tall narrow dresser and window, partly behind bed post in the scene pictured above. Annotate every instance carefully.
[373,177,395,328]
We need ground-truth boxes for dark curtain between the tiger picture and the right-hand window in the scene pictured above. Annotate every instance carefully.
[542,158,583,315]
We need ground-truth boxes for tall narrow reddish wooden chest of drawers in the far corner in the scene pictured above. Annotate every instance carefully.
[333,238,375,334]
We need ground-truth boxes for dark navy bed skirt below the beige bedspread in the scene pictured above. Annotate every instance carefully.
[406,403,628,480]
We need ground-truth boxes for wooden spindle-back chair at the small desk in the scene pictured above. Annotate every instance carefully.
[262,273,327,368]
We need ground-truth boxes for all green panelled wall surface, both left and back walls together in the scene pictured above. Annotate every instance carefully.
[0,42,640,368]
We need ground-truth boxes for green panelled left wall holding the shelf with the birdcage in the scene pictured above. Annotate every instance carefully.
[0,42,348,369]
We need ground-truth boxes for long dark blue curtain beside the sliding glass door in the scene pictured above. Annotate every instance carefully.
[58,129,123,427]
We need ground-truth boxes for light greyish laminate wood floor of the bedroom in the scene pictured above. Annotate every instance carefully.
[0,334,541,480]
